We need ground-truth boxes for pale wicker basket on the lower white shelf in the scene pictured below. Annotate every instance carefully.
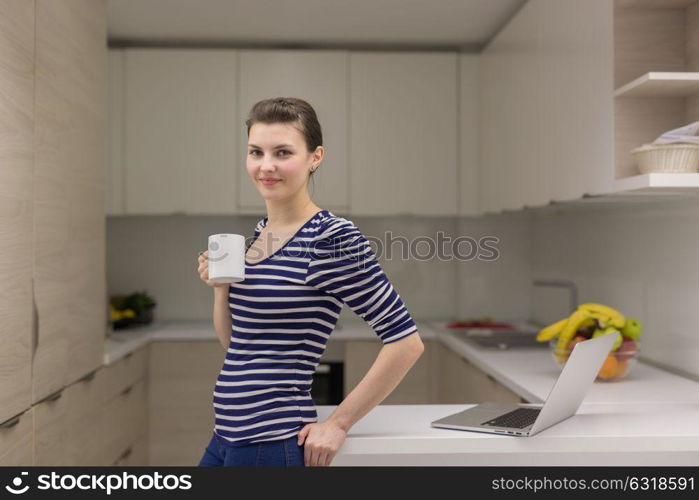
[631,143,699,174]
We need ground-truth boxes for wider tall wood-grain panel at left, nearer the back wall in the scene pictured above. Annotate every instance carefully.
[33,0,107,401]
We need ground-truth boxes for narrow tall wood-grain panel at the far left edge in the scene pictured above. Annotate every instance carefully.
[0,0,34,422]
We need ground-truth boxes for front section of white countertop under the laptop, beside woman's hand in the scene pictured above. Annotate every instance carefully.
[316,403,699,466]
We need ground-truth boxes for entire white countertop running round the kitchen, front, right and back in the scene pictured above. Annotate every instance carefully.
[105,320,699,466]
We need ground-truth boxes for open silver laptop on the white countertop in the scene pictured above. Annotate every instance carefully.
[430,332,621,436]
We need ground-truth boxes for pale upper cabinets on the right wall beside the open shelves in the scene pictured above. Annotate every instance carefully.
[481,0,613,212]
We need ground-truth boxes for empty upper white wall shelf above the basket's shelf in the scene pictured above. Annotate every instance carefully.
[614,71,699,97]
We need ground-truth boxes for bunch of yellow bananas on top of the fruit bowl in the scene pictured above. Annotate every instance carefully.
[536,302,641,352]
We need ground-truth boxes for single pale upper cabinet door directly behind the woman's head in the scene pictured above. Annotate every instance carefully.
[235,50,349,211]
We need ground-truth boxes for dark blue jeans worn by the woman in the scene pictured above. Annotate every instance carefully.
[199,433,304,467]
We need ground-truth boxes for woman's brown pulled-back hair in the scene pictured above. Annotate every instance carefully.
[245,97,323,153]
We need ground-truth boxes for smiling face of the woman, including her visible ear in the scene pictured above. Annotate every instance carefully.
[245,123,322,200]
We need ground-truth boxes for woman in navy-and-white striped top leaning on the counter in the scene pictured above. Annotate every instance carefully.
[198,98,424,466]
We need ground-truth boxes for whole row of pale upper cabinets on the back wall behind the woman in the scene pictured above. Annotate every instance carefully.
[106,48,470,216]
